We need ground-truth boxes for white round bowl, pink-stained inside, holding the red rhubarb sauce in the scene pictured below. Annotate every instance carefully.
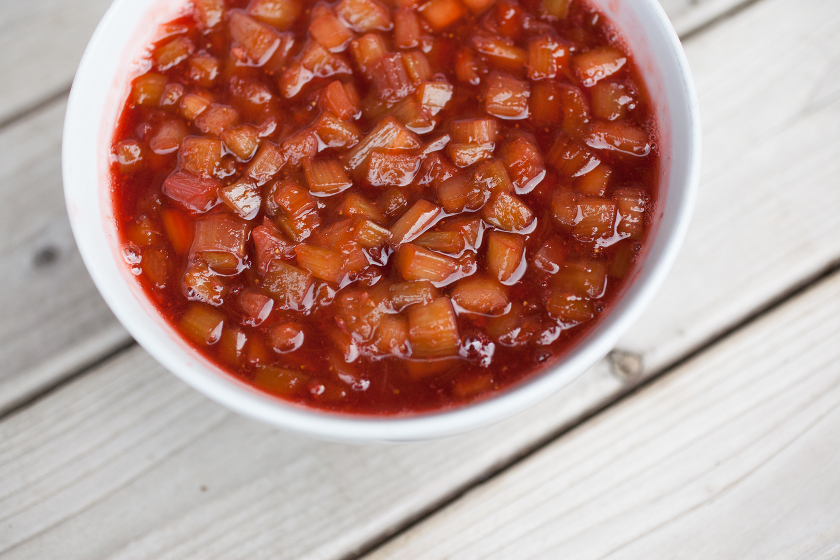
[63,0,700,442]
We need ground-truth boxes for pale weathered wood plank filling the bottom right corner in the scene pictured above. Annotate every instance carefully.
[366,274,840,560]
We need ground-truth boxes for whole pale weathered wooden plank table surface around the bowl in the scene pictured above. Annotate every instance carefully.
[0,0,840,560]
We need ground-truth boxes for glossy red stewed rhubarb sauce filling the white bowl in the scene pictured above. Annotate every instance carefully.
[111,0,659,415]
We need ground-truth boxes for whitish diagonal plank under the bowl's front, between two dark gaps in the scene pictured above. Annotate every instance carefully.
[0,0,840,559]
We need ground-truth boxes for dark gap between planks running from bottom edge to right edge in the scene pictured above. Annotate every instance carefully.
[341,256,840,560]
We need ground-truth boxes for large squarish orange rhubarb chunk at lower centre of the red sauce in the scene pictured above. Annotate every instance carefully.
[408,297,461,359]
